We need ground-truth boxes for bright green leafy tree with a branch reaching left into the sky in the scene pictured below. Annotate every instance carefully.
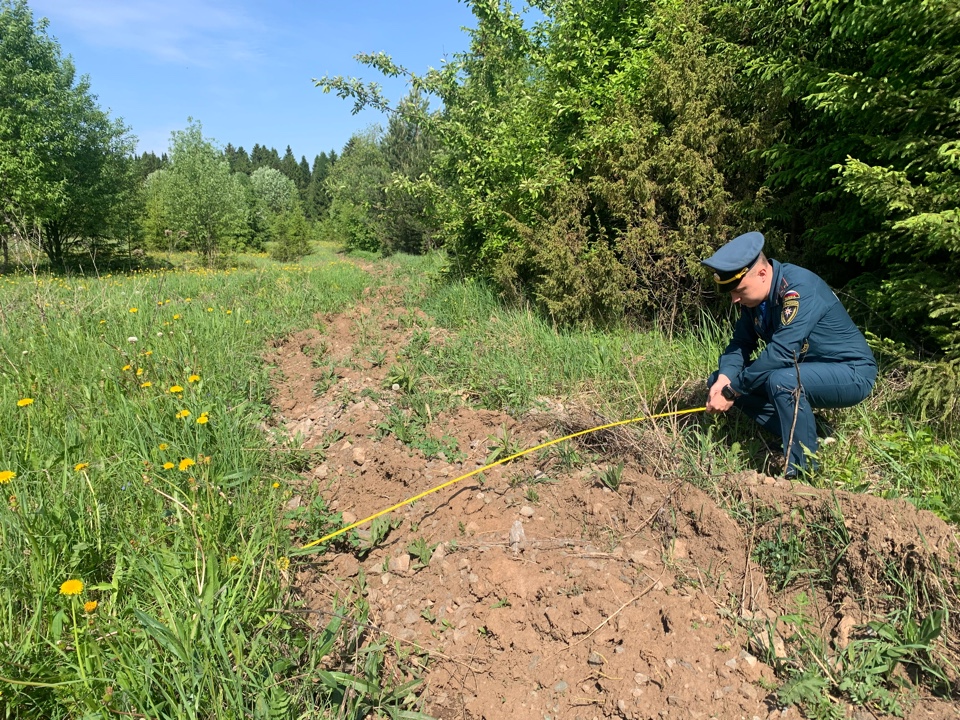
[317,0,548,276]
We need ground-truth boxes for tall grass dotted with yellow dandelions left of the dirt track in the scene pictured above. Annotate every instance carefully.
[0,246,370,718]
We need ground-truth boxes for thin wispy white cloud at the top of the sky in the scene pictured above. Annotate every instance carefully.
[31,0,265,68]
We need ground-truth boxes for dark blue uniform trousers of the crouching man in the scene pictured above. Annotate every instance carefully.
[707,362,877,475]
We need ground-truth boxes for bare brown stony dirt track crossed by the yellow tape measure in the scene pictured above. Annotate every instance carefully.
[269,278,957,720]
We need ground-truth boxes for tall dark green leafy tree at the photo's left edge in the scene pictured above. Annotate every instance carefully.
[0,0,136,265]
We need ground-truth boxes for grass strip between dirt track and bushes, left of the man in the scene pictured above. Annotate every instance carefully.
[416,283,717,417]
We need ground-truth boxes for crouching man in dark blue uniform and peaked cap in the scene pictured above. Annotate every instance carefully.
[703,232,877,478]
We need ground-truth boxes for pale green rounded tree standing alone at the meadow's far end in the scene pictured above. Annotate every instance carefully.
[147,121,248,263]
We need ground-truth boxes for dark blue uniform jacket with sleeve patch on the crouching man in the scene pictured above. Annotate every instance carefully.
[720,260,876,394]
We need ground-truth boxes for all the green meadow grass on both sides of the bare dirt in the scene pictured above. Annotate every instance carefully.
[0,249,960,718]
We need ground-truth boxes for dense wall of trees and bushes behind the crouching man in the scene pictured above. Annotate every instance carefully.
[318,0,960,417]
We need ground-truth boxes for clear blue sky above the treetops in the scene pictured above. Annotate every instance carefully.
[29,0,475,162]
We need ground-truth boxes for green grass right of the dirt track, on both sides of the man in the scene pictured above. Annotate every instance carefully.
[392,256,960,523]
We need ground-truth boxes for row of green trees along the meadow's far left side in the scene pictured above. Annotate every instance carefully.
[0,0,337,268]
